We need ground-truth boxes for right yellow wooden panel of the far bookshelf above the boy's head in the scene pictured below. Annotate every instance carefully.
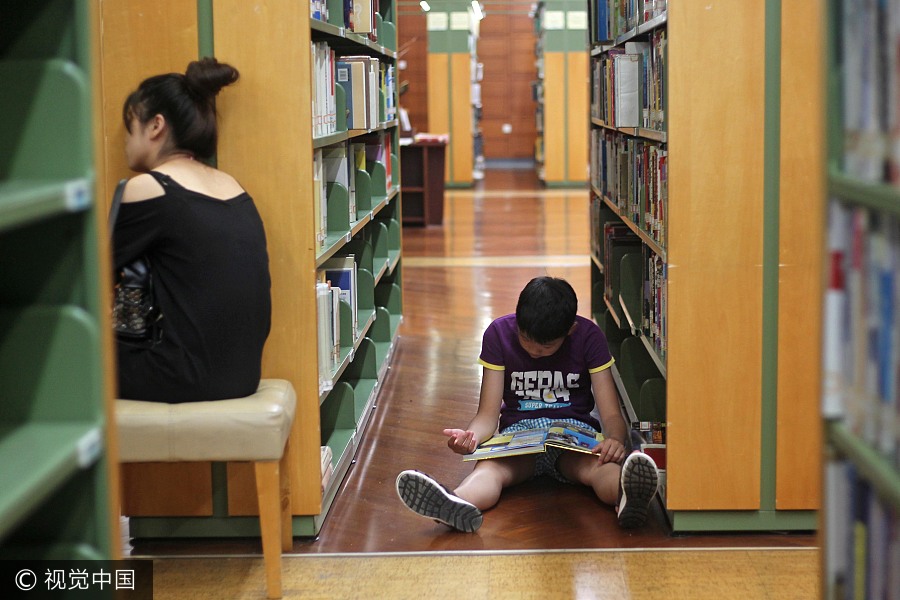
[566,52,590,181]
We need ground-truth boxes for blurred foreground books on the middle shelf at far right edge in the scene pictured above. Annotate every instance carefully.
[822,200,900,469]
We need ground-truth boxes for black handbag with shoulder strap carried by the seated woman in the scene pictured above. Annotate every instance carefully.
[109,179,163,345]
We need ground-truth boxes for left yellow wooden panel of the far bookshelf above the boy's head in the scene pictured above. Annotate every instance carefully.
[544,52,564,182]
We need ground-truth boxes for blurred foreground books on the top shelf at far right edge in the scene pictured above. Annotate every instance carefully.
[838,0,900,186]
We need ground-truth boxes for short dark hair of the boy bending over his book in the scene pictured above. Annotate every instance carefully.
[516,276,578,344]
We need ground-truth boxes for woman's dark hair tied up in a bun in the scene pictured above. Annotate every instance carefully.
[122,58,240,160]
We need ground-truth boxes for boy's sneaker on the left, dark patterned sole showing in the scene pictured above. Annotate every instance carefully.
[397,471,482,533]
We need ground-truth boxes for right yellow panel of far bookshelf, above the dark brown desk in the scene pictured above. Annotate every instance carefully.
[447,53,475,183]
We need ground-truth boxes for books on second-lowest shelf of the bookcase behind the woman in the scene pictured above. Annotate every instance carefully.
[316,254,359,394]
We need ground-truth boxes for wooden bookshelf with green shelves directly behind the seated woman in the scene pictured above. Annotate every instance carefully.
[97,0,402,537]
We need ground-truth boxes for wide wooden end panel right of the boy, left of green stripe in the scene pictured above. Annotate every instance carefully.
[667,2,765,510]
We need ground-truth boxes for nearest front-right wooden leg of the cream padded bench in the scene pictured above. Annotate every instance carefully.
[254,461,282,598]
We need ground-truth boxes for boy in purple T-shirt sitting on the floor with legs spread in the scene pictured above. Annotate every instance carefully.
[397,277,659,532]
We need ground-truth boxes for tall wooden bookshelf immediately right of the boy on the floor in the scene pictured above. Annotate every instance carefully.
[589,0,822,531]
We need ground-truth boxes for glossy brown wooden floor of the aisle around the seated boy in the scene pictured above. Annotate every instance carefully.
[134,170,818,598]
